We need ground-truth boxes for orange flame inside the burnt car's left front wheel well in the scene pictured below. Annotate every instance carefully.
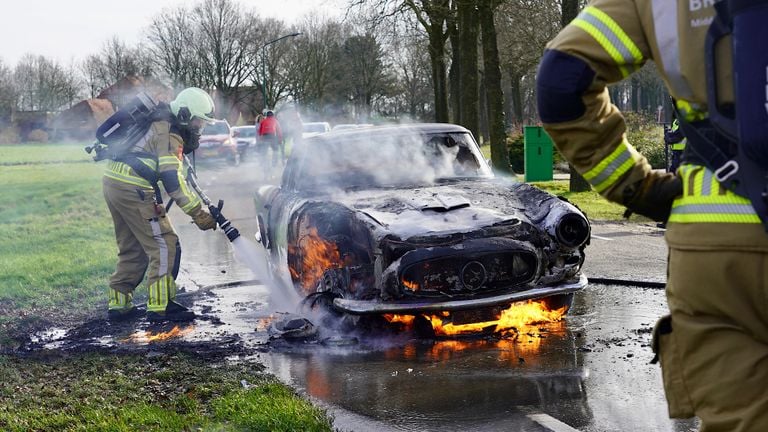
[290,227,342,292]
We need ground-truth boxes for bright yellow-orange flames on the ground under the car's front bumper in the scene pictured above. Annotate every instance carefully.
[384,300,568,336]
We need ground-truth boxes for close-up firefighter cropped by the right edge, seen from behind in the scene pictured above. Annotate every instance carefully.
[537,0,768,432]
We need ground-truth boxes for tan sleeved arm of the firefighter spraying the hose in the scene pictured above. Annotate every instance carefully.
[158,133,202,215]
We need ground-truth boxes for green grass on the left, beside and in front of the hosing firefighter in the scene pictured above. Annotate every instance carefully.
[0,143,333,432]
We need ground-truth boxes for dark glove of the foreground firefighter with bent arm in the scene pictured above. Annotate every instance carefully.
[624,172,683,222]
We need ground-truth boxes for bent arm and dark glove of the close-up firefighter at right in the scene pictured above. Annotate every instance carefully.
[537,0,677,220]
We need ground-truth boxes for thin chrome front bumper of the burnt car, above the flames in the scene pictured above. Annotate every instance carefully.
[333,274,588,315]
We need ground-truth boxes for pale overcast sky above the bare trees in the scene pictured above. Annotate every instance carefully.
[0,0,344,67]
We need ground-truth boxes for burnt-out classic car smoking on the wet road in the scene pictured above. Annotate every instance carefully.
[255,124,590,332]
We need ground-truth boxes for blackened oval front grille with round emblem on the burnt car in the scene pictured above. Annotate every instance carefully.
[399,251,537,297]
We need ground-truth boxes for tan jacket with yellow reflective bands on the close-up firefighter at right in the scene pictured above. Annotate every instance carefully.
[537,0,768,248]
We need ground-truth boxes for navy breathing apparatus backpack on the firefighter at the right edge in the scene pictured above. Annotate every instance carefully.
[677,0,768,231]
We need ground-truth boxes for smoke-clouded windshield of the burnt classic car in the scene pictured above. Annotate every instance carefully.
[293,132,492,190]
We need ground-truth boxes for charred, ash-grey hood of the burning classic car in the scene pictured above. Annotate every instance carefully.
[326,179,556,239]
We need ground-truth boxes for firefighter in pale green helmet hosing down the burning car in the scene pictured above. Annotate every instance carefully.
[102,87,216,321]
